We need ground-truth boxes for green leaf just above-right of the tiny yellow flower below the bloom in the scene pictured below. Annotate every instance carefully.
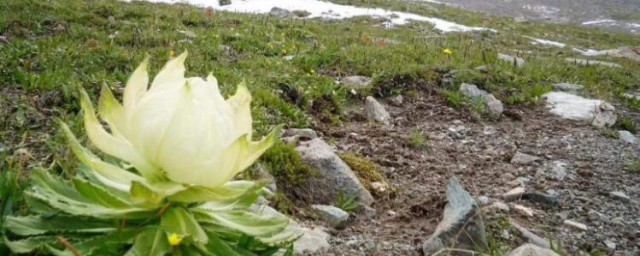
[160,207,209,244]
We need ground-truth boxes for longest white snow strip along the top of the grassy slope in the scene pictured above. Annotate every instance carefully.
[124,0,496,32]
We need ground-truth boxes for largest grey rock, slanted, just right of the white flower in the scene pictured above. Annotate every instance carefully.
[296,138,373,205]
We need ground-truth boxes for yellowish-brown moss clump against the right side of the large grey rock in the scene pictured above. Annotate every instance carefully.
[340,153,386,192]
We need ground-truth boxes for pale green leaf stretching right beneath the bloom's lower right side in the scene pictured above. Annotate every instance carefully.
[194,209,289,237]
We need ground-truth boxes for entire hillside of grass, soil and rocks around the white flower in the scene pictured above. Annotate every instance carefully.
[0,0,640,255]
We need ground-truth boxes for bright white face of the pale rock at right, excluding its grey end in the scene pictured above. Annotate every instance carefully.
[542,92,605,121]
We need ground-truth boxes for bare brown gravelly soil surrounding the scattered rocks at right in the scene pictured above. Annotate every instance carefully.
[316,89,640,255]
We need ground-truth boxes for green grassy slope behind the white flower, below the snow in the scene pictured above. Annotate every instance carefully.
[0,0,640,236]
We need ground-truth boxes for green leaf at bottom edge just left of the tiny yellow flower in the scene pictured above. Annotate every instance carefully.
[127,227,171,256]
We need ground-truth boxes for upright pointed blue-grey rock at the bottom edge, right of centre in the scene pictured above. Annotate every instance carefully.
[422,177,488,255]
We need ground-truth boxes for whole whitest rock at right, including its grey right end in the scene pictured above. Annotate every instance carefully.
[542,92,617,127]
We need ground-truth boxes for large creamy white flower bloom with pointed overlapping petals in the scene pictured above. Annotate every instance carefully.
[68,53,276,190]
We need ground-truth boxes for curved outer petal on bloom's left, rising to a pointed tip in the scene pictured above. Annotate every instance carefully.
[80,90,160,180]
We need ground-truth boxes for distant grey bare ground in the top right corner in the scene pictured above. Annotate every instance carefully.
[418,0,640,34]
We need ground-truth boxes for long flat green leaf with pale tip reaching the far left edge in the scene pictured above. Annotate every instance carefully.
[4,215,116,236]
